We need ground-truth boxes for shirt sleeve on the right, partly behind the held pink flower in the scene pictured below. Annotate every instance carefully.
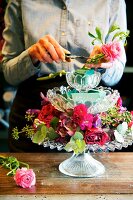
[102,0,127,86]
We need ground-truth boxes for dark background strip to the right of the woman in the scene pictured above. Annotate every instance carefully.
[113,0,133,110]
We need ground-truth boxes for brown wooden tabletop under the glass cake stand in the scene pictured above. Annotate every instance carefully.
[0,152,133,200]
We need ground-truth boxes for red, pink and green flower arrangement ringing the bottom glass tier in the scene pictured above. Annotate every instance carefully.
[13,93,133,154]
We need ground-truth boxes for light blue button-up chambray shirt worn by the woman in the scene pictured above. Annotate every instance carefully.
[2,0,127,86]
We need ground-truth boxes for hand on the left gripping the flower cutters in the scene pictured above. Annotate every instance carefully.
[28,35,70,64]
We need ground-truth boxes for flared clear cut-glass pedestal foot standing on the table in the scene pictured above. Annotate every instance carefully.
[59,153,105,177]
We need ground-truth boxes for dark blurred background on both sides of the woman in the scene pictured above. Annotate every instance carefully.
[0,0,133,152]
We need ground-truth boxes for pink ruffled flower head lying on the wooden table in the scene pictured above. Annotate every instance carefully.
[14,167,36,188]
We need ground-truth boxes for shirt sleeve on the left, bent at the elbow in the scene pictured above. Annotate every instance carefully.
[2,1,39,85]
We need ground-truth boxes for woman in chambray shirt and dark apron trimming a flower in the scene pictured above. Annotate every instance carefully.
[3,0,126,152]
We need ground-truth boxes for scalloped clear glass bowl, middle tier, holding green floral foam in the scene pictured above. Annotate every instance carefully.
[47,86,120,114]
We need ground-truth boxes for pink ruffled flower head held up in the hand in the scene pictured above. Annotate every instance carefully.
[101,41,121,62]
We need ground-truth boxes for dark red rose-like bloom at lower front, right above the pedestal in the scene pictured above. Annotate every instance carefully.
[84,128,110,145]
